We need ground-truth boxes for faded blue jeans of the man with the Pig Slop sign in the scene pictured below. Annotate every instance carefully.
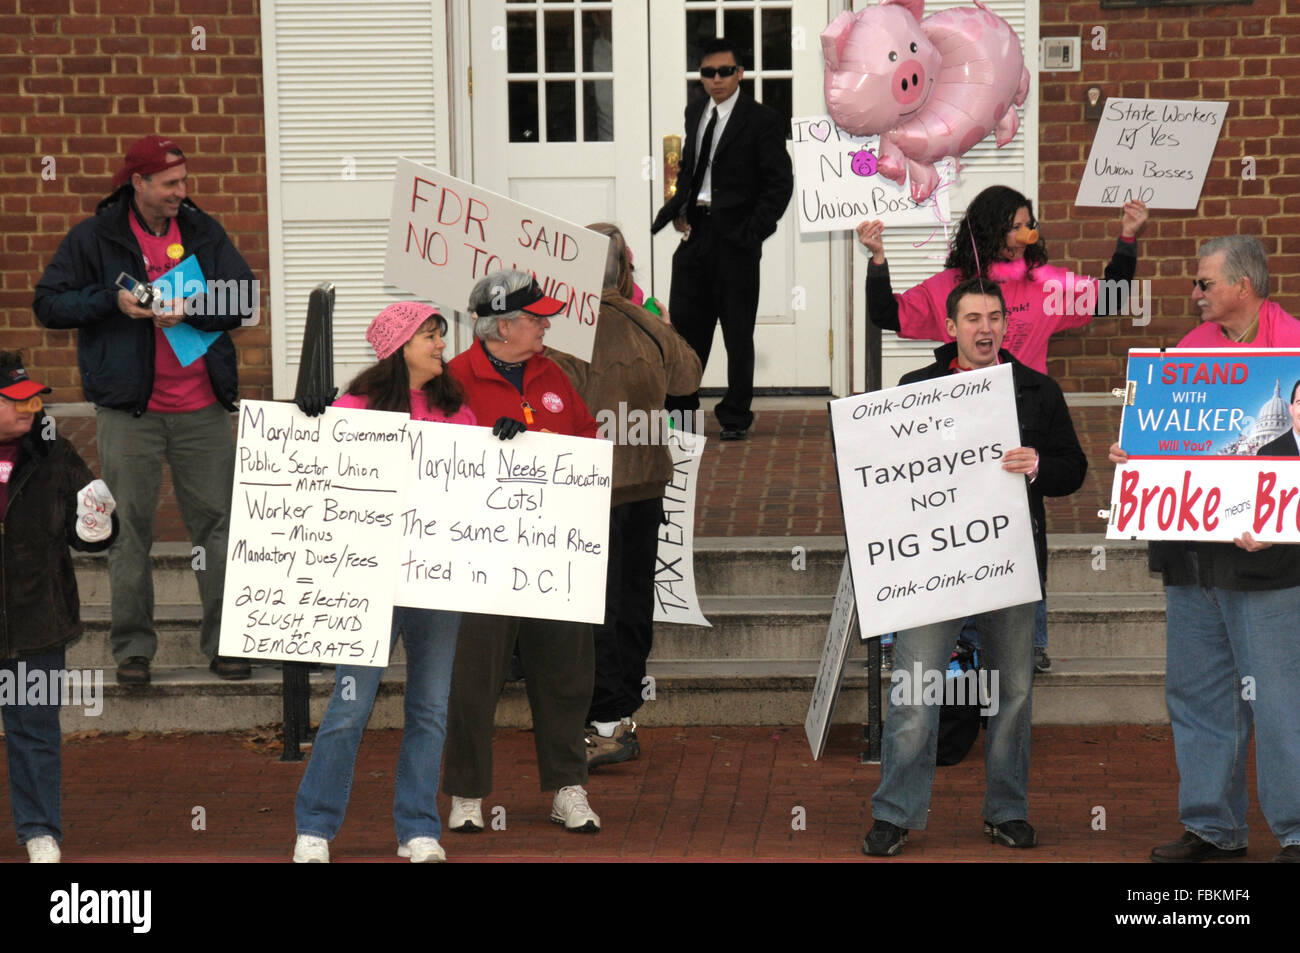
[871,602,1034,831]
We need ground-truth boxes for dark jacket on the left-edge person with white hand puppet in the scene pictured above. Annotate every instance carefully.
[0,413,117,659]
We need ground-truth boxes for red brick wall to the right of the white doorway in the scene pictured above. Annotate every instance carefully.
[1036,0,1300,391]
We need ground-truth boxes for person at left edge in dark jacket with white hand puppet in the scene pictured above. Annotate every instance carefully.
[0,351,117,863]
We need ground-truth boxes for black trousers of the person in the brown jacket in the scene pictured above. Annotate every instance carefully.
[588,497,663,722]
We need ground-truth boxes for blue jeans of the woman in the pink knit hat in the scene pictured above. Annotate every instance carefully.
[294,607,460,844]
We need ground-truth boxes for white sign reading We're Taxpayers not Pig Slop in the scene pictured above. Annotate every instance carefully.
[831,364,1041,637]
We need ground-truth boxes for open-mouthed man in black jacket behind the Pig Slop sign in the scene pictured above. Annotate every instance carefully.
[862,278,1088,857]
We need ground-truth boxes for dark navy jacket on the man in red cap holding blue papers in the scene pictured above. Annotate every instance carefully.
[33,183,256,416]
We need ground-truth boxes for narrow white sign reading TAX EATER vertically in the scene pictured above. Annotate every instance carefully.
[654,430,712,628]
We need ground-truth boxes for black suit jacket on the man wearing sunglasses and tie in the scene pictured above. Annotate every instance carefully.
[650,90,794,246]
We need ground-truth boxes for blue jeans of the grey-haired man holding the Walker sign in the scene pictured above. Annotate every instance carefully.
[1165,586,1300,850]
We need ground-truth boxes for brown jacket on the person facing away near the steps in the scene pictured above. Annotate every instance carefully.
[546,289,703,506]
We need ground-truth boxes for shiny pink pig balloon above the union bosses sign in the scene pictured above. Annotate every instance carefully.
[822,0,1030,203]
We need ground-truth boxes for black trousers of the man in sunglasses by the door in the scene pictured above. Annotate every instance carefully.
[666,212,763,430]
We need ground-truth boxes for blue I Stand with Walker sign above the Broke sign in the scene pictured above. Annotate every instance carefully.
[1119,348,1300,458]
